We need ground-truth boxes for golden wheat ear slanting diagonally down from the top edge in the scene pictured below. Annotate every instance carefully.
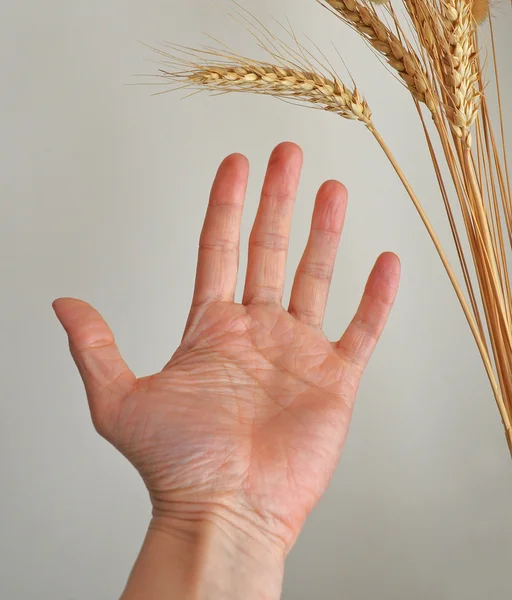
[324,0,438,113]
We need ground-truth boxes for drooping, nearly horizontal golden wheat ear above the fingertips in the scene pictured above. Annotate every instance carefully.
[163,63,372,128]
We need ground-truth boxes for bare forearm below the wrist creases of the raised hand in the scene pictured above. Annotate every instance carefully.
[121,510,284,600]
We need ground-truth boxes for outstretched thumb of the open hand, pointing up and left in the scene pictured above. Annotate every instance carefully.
[53,298,136,433]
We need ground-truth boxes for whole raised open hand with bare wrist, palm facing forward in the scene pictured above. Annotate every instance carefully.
[54,143,400,600]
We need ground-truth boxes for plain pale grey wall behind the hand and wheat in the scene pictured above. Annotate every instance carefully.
[0,0,512,600]
